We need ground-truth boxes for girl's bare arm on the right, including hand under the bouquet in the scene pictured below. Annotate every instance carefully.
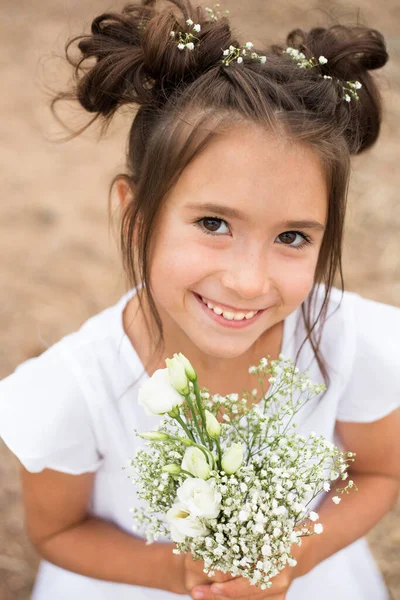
[192,411,400,600]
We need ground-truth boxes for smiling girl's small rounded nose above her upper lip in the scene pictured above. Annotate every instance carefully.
[222,247,272,300]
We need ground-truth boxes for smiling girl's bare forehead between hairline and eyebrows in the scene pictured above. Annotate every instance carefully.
[175,124,328,219]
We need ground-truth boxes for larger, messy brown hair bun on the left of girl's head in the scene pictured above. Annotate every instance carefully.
[63,0,233,121]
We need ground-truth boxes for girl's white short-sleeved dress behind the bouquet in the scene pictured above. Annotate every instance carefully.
[0,287,400,600]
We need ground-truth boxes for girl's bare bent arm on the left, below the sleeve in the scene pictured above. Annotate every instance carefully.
[22,467,192,594]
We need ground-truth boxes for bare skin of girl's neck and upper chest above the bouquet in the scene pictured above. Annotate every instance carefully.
[123,294,283,395]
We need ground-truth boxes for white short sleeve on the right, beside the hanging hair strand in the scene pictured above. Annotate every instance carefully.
[337,294,400,423]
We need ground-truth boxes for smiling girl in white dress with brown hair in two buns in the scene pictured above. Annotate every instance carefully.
[0,0,400,600]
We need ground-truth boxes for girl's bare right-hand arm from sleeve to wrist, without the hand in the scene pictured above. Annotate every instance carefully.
[299,410,400,572]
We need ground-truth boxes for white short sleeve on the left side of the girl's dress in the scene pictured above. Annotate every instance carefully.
[0,344,101,475]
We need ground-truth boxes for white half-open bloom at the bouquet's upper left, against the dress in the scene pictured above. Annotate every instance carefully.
[139,369,185,415]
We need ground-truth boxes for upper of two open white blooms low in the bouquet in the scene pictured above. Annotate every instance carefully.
[177,477,222,519]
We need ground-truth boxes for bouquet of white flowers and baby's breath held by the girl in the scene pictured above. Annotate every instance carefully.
[126,354,356,589]
